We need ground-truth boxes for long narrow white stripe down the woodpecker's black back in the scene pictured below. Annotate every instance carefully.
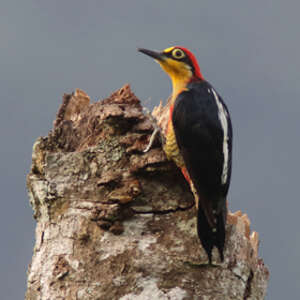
[211,89,229,184]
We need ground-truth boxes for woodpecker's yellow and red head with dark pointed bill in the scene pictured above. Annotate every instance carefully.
[138,46,203,88]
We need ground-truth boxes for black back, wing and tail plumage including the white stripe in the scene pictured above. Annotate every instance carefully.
[172,80,232,263]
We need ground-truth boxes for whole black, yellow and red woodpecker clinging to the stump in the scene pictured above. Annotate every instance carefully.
[138,46,233,265]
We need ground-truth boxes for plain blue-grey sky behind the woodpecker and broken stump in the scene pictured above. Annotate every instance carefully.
[0,0,300,300]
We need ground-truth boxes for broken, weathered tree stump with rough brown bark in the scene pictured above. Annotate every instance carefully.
[26,85,269,300]
